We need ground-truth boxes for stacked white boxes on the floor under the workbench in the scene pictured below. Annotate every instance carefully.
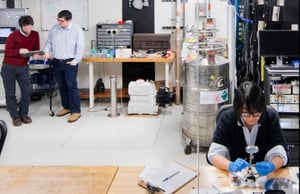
[128,80,158,114]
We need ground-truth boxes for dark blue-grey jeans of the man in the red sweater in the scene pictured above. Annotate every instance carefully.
[1,64,31,119]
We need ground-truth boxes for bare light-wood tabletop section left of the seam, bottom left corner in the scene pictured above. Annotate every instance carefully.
[0,166,118,194]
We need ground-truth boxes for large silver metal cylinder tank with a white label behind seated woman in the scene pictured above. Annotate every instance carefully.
[182,44,229,147]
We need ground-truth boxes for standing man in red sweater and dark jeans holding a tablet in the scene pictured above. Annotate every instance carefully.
[1,15,40,126]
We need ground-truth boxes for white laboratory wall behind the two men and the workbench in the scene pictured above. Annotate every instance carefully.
[0,0,227,88]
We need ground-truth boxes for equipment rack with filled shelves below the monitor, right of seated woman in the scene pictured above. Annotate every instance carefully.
[264,66,299,166]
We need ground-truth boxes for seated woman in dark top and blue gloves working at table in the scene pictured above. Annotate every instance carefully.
[207,82,288,176]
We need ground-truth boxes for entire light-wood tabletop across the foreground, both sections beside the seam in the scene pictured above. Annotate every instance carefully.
[0,166,299,194]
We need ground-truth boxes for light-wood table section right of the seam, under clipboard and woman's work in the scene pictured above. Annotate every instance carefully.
[108,166,299,194]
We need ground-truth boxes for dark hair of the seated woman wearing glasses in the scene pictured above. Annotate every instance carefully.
[233,81,267,119]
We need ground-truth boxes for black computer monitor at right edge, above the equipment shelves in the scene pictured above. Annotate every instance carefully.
[258,30,299,57]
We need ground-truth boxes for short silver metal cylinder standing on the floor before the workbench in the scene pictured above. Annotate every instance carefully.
[108,76,120,117]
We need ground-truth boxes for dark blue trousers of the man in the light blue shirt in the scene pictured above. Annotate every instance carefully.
[52,59,81,113]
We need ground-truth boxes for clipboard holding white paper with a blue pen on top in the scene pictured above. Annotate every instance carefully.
[138,162,197,194]
